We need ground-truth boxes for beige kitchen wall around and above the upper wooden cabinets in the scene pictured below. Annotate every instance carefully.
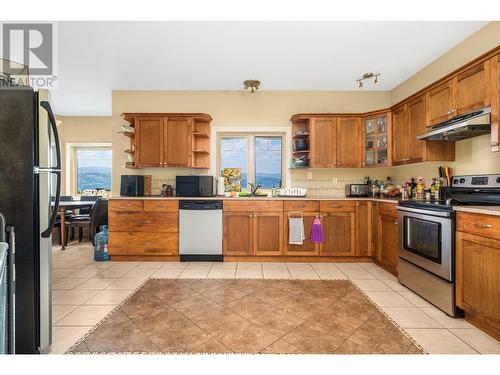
[56,22,500,195]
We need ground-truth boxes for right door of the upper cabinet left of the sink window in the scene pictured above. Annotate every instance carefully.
[163,117,192,167]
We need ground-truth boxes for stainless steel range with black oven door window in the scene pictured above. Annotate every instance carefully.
[398,174,500,316]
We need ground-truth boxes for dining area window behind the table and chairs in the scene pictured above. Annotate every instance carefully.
[75,147,112,194]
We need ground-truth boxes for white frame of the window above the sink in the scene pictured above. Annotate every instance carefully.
[215,131,288,191]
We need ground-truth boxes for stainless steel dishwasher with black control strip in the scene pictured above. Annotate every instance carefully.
[179,200,223,262]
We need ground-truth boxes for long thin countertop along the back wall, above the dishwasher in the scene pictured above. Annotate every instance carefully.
[109,195,399,204]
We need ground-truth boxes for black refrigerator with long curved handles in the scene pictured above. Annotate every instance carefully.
[0,87,61,354]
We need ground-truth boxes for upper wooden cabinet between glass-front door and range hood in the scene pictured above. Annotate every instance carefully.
[392,95,455,165]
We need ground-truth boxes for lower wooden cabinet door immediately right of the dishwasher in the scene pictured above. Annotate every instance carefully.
[222,211,254,256]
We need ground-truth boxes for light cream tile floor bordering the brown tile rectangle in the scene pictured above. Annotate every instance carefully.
[51,243,500,354]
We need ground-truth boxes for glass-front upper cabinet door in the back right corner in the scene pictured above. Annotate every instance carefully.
[363,112,389,168]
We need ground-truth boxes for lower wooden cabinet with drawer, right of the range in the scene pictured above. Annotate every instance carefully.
[456,212,500,340]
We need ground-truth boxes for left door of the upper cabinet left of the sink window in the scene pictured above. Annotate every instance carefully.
[135,116,163,168]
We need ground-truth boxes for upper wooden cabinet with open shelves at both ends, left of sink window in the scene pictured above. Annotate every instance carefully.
[122,113,212,168]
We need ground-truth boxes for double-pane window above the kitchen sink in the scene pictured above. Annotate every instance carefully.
[219,134,283,189]
